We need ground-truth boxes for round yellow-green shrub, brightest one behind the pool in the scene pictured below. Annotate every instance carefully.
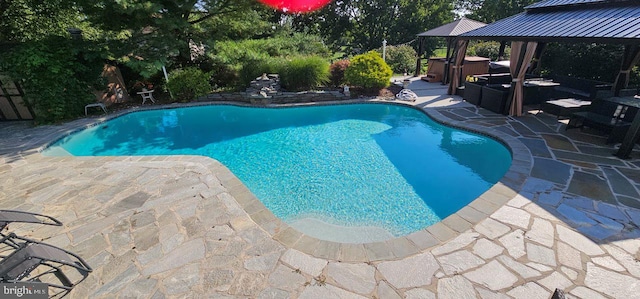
[344,51,393,89]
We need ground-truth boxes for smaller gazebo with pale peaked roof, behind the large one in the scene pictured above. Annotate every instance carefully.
[414,17,487,82]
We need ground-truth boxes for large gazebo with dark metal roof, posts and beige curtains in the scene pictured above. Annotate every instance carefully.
[449,0,640,159]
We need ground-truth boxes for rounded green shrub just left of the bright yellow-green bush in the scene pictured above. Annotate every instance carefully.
[280,56,329,91]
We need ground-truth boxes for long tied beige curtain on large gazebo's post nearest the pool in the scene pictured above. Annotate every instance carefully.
[509,42,538,116]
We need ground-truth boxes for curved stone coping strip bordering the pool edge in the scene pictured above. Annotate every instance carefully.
[38,99,533,262]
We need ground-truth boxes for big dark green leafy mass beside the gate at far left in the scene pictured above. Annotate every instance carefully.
[0,36,105,123]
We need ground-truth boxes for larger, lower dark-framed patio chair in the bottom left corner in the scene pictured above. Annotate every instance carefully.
[0,233,93,298]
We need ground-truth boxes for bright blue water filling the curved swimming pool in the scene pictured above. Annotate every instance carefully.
[44,104,511,240]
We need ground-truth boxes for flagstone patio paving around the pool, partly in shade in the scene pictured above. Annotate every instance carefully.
[0,81,640,299]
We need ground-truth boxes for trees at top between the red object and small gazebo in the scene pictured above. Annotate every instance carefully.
[284,0,453,52]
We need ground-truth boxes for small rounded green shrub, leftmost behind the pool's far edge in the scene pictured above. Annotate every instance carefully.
[167,67,211,102]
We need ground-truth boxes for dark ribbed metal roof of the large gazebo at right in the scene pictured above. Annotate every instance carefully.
[459,0,640,44]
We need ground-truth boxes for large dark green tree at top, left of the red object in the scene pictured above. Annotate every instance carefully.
[79,0,272,75]
